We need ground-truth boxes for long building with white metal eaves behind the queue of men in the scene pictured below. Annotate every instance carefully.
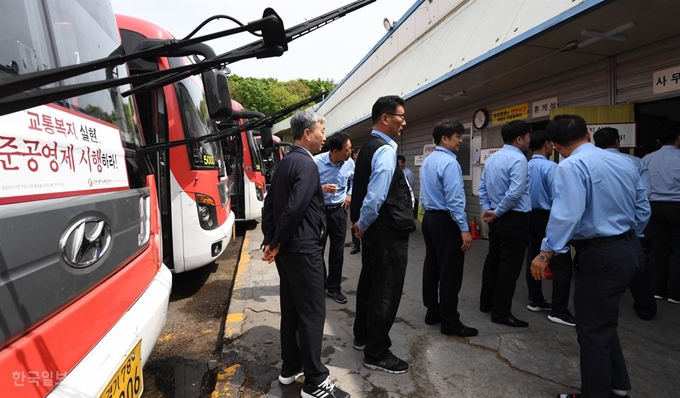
[274,0,680,235]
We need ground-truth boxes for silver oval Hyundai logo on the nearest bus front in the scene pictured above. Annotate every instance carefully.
[60,217,111,268]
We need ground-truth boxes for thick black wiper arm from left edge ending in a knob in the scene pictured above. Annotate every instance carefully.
[0,8,285,98]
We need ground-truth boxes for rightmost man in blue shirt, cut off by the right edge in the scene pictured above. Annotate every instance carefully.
[642,121,680,304]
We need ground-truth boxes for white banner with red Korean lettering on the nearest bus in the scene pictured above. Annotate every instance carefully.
[0,105,128,203]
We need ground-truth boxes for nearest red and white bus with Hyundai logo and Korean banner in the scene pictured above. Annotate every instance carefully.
[0,0,172,398]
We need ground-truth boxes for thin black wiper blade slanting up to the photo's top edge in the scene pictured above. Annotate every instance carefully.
[123,0,376,96]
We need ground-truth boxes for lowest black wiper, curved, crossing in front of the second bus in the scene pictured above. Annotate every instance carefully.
[136,90,326,155]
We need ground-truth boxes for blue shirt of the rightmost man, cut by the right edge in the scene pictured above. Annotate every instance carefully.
[642,145,680,202]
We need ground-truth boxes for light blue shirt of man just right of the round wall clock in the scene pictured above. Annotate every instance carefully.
[479,144,531,217]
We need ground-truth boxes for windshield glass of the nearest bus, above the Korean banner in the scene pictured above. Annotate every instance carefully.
[0,0,142,183]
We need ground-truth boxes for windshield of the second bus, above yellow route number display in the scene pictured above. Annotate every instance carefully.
[168,57,223,169]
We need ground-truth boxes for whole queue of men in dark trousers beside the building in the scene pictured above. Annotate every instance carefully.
[262,96,680,398]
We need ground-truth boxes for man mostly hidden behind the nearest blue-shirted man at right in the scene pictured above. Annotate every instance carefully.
[596,127,657,320]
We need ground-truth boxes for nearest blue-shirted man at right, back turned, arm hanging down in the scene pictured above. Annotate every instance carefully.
[531,115,651,398]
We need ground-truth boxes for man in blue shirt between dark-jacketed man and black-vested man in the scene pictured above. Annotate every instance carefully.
[314,132,354,304]
